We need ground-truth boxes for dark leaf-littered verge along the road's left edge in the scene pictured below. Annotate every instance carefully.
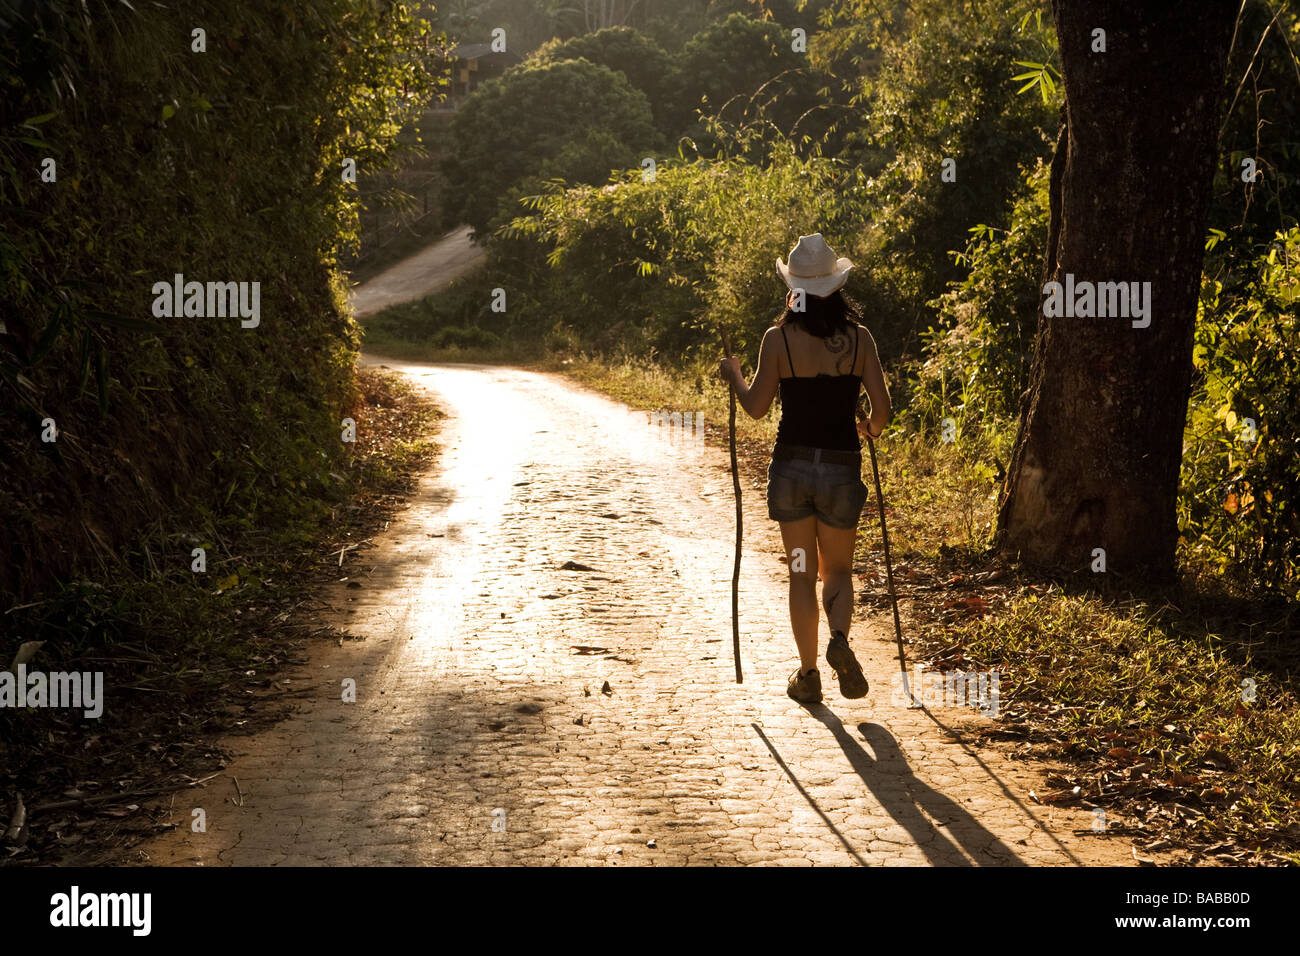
[0,369,438,865]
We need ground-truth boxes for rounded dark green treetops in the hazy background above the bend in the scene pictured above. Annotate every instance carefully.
[443,13,847,235]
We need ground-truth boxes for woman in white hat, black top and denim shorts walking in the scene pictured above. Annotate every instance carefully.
[719,233,889,704]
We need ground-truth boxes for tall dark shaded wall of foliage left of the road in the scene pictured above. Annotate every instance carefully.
[0,0,433,593]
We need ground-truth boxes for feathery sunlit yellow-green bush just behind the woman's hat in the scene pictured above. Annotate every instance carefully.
[494,130,862,355]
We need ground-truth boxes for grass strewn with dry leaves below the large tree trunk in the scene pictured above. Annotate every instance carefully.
[924,583,1300,865]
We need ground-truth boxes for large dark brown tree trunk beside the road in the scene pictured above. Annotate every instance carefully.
[998,0,1236,579]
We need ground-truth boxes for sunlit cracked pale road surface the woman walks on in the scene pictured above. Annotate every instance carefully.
[144,359,1132,866]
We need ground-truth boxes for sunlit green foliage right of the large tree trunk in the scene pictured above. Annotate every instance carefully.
[1178,0,1300,596]
